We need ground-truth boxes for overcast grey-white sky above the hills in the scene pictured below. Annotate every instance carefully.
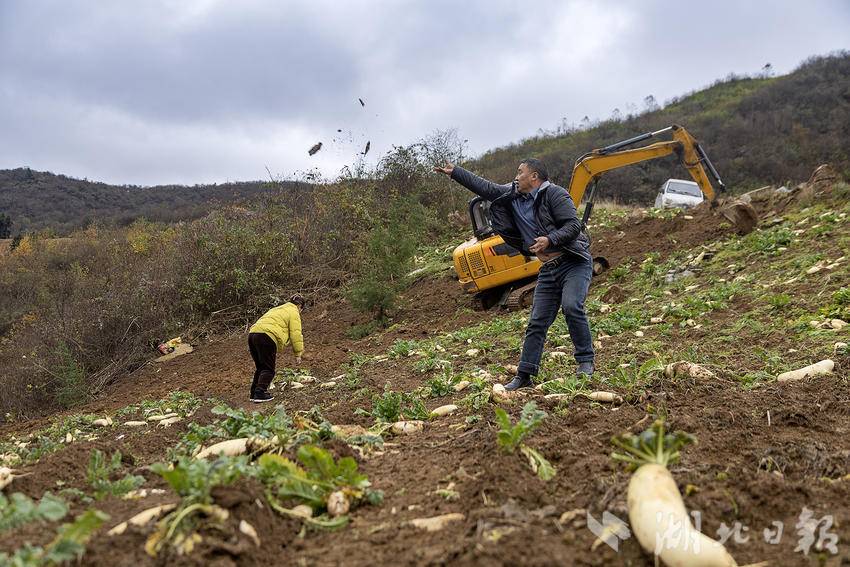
[0,0,850,185]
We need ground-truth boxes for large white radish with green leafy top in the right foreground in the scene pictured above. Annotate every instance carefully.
[611,420,738,567]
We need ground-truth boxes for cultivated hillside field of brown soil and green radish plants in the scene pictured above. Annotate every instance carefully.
[0,171,850,566]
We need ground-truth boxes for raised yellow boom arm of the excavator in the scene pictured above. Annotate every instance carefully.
[569,124,726,225]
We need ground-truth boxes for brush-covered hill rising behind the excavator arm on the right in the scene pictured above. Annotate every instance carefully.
[470,52,850,205]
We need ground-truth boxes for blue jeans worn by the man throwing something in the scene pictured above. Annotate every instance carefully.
[519,253,593,375]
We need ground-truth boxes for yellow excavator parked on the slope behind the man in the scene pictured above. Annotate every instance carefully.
[453,124,757,309]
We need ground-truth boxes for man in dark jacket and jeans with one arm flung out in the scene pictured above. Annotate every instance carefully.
[434,158,594,390]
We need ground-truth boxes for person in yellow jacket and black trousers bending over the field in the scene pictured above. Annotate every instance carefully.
[248,295,304,404]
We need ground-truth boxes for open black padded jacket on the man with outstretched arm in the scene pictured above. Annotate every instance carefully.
[452,166,592,261]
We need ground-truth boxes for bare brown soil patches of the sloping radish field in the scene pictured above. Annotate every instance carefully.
[0,189,850,567]
